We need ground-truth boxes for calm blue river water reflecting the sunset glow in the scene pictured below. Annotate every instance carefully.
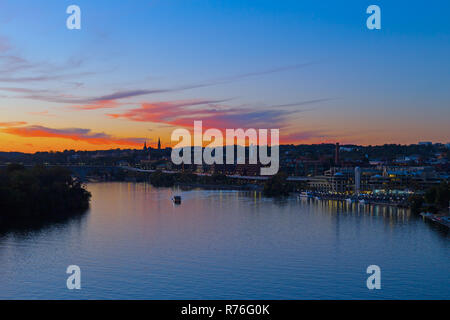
[0,183,450,299]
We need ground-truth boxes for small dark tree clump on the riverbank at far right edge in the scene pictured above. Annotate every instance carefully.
[409,182,450,213]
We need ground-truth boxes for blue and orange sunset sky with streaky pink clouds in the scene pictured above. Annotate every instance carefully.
[0,0,450,152]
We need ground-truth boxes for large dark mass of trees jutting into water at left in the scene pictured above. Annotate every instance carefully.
[0,164,91,222]
